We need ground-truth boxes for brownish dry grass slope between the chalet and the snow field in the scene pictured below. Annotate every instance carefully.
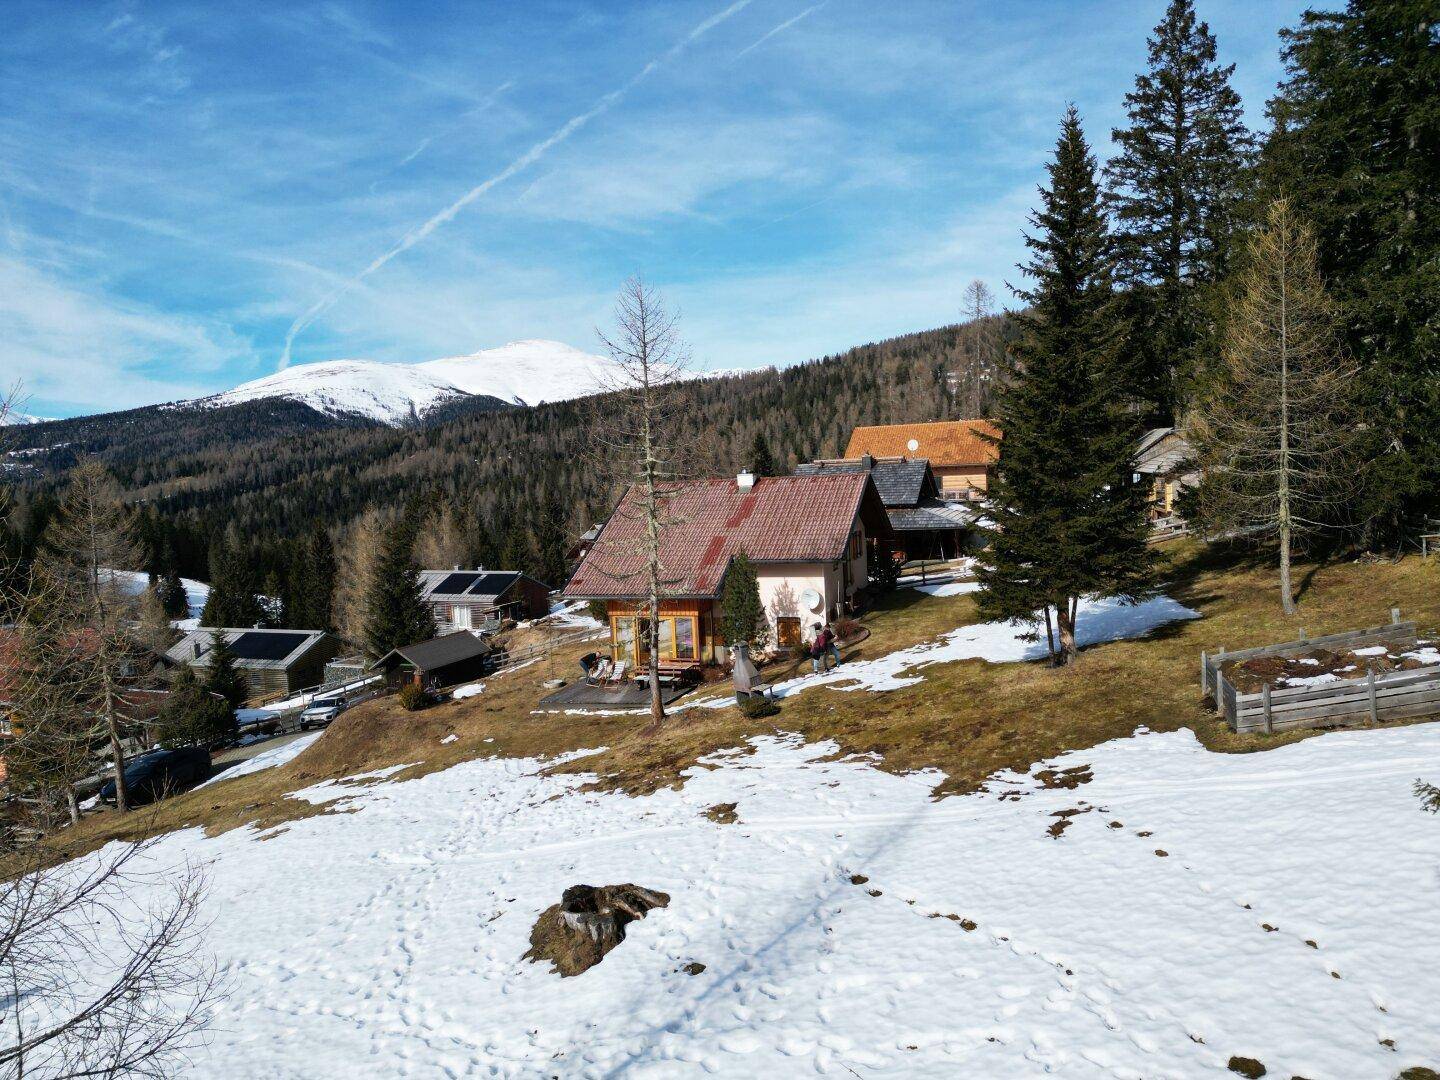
[39,543,1440,855]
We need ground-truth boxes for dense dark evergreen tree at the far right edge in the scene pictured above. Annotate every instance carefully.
[1263,0,1440,546]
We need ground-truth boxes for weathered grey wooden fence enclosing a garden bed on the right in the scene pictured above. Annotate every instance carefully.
[1200,609,1440,734]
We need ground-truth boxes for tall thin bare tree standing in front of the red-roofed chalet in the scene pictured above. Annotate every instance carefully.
[593,276,690,729]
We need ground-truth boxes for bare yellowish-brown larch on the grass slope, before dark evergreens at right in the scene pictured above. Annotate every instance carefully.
[1188,199,1356,615]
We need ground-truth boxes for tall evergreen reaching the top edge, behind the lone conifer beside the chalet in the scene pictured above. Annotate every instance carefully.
[1106,0,1254,422]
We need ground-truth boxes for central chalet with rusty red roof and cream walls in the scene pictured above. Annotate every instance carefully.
[564,472,891,665]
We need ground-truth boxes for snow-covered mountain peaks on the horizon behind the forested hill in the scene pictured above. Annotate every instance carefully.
[196,341,608,425]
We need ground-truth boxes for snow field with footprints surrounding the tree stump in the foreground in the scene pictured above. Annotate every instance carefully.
[56,724,1440,1080]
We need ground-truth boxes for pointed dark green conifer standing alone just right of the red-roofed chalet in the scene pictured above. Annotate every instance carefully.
[976,105,1155,664]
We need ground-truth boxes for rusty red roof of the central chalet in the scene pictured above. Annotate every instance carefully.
[564,472,888,599]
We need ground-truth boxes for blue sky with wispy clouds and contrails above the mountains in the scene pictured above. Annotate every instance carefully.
[0,0,1302,416]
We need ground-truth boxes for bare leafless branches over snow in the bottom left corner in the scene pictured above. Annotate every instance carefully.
[0,841,225,1080]
